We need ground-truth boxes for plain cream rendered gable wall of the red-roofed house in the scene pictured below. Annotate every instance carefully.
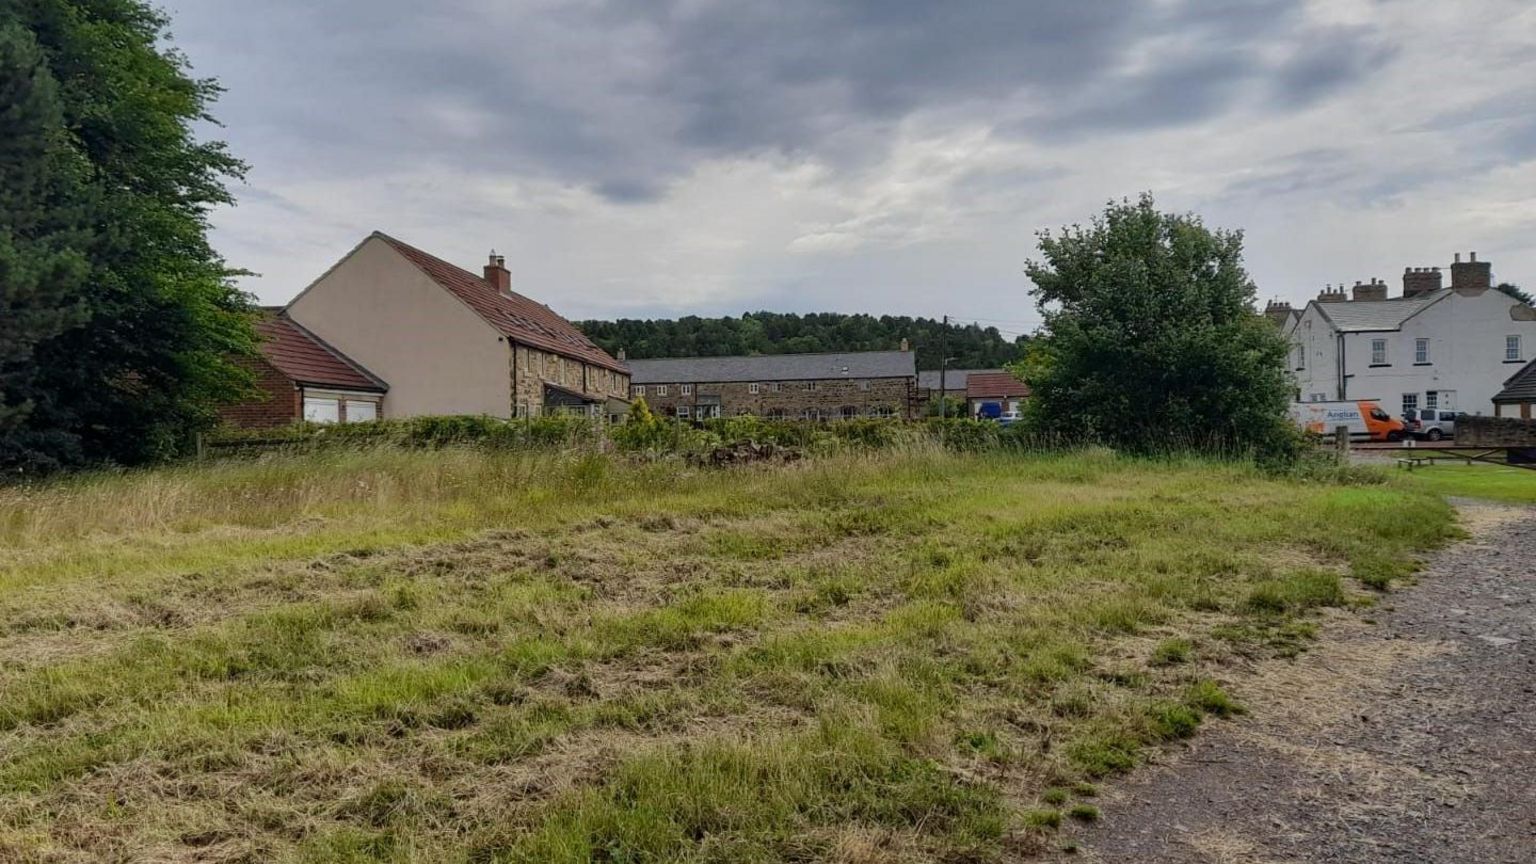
[287,237,511,418]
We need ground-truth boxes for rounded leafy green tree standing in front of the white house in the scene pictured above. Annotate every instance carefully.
[1018,195,1295,452]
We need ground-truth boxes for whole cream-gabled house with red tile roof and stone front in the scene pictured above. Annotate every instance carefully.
[283,232,630,418]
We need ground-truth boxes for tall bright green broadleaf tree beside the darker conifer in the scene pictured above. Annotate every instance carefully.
[0,0,252,467]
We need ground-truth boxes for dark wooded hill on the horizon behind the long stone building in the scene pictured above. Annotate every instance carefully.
[576,312,1028,369]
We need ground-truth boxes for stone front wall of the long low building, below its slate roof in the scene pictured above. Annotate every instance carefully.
[631,378,917,420]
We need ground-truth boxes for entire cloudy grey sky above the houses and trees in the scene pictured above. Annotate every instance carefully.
[164,0,1536,331]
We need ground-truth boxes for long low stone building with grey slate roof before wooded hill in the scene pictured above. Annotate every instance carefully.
[630,346,917,420]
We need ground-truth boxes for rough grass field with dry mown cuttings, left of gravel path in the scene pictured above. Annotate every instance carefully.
[0,450,1455,862]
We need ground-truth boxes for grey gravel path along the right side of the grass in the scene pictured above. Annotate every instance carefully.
[1060,501,1536,864]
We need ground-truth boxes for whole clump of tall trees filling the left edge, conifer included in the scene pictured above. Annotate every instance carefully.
[0,0,253,477]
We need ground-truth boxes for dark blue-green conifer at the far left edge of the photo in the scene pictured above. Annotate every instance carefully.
[0,22,88,441]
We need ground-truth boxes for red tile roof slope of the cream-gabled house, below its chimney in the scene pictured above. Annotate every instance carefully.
[375,232,628,372]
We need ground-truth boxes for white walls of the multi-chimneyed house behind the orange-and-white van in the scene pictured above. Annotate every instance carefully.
[1289,291,1536,415]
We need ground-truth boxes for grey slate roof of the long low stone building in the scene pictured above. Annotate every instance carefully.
[630,351,917,384]
